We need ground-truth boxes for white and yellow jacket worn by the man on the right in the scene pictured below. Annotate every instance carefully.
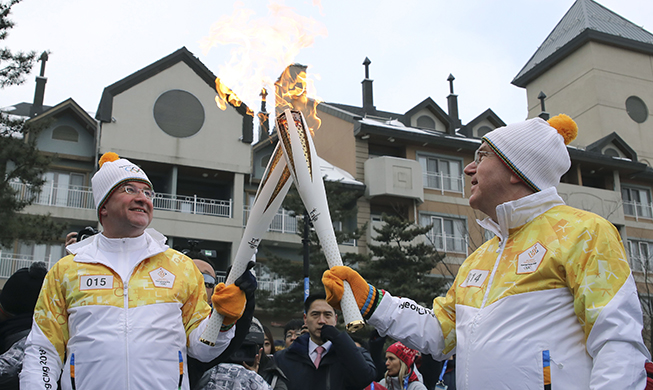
[370,188,650,390]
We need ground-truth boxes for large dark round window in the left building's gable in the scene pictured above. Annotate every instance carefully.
[154,89,204,138]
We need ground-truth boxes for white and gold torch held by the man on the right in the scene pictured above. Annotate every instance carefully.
[277,109,365,332]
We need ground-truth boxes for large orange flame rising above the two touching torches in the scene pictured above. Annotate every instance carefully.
[200,0,327,134]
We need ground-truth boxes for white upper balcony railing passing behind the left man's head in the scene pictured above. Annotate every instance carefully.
[11,182,233,218]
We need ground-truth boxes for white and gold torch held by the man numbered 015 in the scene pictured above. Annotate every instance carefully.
[200,144,292,345]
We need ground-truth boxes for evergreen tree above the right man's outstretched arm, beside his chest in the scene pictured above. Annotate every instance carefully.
[358,214,446,307]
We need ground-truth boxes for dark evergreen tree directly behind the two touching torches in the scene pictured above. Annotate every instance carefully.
[256,181,366,315]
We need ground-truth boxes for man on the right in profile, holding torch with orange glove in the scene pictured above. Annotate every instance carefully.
[322,115,650,390]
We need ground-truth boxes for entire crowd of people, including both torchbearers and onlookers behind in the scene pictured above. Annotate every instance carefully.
[0,115,653,390]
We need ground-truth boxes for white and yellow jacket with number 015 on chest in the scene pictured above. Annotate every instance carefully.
[20,229,234,390]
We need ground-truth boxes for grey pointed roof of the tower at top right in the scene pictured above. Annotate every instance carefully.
[512,0,653,87]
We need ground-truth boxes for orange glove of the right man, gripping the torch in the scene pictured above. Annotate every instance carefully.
[322,265,383,319]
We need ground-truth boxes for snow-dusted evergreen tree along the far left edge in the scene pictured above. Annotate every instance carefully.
[0,0,65,247]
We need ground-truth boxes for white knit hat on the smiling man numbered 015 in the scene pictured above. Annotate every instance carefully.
[91,152,153,219]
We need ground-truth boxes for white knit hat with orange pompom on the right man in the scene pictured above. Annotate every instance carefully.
[483,114,578,192]
